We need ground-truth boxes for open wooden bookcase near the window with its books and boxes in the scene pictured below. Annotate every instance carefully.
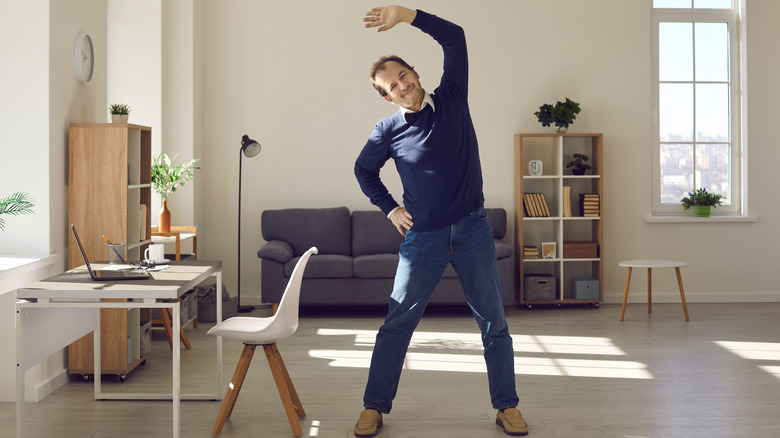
[515,133,604,307]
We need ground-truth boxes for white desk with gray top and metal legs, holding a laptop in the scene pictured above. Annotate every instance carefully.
[16,261,222,438]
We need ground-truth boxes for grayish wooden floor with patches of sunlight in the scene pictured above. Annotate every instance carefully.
[0,303,780,438]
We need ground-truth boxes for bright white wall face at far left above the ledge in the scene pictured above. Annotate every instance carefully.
[0,0,49,256]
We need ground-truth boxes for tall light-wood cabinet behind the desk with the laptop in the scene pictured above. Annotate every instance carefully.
[68,123,152,376]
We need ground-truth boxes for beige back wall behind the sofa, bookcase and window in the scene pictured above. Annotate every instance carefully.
[199,0,780,302]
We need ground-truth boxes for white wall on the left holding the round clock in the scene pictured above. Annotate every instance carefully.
[0,0,107,400]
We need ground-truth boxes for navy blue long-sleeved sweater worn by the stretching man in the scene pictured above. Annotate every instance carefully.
[355,10,484,231]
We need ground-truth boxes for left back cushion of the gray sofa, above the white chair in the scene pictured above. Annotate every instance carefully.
[261,207,352,256]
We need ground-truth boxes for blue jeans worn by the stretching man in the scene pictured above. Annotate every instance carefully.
[363,207,518,414]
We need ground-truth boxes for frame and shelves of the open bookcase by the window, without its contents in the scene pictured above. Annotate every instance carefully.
[515,133,604,308]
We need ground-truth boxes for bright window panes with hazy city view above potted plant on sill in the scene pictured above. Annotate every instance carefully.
[658,17,733,205]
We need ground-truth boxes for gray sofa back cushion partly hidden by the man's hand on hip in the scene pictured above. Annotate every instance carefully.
[352,210,404,256]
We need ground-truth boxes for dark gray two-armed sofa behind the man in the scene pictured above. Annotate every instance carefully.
[257,207,514,305]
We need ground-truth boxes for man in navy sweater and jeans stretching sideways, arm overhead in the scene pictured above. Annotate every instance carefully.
[355,6,528,437]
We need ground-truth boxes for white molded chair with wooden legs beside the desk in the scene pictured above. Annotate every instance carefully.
[208,247,317,436]
